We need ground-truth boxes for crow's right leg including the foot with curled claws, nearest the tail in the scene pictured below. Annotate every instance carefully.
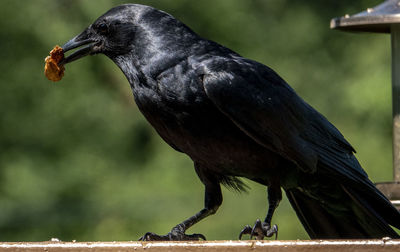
[239,185,282,240]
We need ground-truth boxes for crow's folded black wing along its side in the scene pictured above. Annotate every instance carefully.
[203,60,367,182]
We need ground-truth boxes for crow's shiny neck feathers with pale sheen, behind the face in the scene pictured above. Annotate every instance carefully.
[108,9,208,92]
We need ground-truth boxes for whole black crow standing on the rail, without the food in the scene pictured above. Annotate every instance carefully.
[62,4,400,240]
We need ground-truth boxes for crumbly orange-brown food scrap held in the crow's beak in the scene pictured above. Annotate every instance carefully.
[44,45,65,81]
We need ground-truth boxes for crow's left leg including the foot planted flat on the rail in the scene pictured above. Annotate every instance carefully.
[139,171,222,241]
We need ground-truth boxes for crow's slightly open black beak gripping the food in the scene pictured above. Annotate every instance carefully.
[60,31,100,65]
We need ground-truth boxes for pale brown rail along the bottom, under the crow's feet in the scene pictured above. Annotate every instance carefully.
[0,239,400,252]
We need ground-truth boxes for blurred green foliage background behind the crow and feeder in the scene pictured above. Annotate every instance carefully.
[0,0,392,241]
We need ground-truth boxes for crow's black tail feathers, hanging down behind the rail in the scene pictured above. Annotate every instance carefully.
[286,185,400,239]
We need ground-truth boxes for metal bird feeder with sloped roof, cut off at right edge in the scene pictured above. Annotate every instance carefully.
[331,0,400,209]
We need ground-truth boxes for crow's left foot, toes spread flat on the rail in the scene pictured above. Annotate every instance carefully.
[139,225,206,241]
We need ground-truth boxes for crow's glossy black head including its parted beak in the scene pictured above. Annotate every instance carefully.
[62,4,198,64]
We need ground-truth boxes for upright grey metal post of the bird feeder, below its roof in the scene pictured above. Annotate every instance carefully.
[391,24,400,182]
